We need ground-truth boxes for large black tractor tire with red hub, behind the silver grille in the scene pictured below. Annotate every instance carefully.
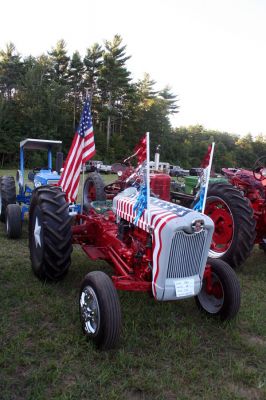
[205,182,256,268]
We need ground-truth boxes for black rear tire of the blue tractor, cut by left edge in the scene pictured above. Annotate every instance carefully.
[0,176,16,222]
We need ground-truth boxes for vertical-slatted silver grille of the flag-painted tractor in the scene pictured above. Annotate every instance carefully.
[167,230,207,278]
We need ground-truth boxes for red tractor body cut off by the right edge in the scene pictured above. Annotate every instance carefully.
[222,156,266,251]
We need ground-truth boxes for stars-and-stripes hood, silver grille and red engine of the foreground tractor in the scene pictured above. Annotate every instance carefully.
[113,187,214,300]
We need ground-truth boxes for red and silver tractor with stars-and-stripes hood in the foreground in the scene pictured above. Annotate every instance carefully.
[29,179,240,349]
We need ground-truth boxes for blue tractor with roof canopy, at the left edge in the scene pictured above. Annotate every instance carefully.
[0,139,63,239]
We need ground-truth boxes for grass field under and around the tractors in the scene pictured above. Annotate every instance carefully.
[0,171,266,400]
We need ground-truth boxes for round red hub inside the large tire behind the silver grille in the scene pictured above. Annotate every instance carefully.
[205,198,234,253]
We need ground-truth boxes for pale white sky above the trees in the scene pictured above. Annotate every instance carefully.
[0,0,266,139]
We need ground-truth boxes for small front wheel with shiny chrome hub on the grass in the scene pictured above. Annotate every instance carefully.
[79,271,121,350]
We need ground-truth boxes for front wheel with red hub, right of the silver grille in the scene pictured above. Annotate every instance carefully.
[195,258,240,321]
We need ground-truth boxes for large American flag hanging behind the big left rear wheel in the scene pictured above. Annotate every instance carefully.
[58,100,95,202]
